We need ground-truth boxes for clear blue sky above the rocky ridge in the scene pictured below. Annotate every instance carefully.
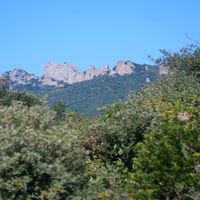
[0,0,200,75]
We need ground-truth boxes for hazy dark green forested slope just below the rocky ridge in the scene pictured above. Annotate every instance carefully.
[16,64,158,116]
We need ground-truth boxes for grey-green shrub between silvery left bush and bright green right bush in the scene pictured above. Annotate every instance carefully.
[90,76,195,170]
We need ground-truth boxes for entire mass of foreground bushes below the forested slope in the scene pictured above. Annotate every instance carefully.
[0,44,200,200]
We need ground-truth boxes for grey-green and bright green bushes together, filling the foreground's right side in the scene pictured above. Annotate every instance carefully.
[82,47,200,200]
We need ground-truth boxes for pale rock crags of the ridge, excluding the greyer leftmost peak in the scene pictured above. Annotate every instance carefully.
[41,61,135,85]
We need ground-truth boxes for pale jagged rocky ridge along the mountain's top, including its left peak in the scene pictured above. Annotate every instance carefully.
[1,61,161,87]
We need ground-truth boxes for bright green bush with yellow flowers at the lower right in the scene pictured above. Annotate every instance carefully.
[133,88,200,199]
